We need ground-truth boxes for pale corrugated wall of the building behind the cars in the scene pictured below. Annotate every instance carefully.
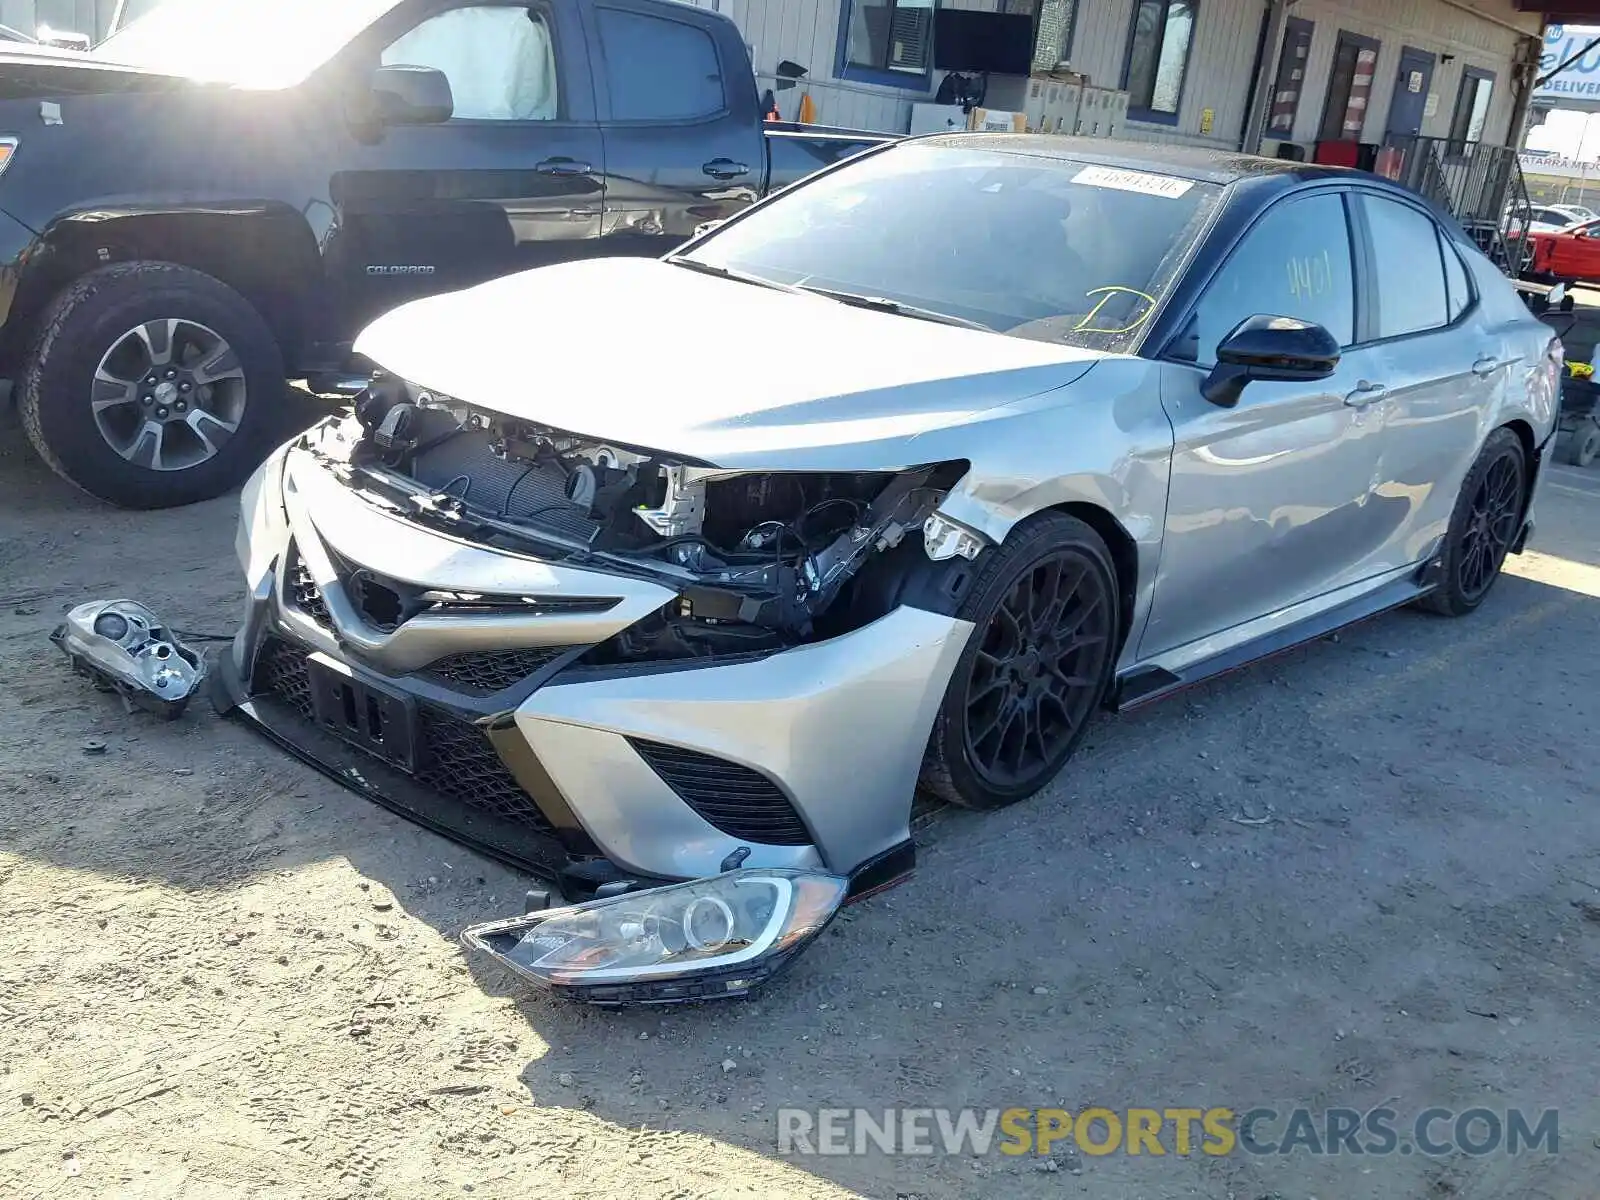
[691,0,1539,149]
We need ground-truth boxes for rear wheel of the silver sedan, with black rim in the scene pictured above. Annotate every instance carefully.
[1418,429,1528,616]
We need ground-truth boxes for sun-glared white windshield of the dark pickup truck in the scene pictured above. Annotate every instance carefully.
[94,0,398,88]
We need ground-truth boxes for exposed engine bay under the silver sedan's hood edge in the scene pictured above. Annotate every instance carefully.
[297,374,982,664]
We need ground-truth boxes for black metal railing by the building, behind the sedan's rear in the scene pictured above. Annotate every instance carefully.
[1374,134,1530,277]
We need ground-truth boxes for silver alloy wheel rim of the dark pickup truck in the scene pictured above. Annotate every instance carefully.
[90,318,248,470]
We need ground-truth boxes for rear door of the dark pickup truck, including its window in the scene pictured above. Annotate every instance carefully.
[587,0,766,254]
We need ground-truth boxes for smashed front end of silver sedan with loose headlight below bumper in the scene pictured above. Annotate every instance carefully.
[216,376,986,1003]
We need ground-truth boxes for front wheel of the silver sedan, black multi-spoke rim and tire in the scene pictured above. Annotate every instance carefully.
[922,512,1120,808]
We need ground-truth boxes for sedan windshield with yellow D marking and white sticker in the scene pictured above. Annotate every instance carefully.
[685,144,1221,350]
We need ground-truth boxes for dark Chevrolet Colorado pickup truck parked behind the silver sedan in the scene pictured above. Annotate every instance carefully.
[0,0,885,507]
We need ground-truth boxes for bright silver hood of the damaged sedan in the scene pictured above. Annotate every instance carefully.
[355,258,1102,467]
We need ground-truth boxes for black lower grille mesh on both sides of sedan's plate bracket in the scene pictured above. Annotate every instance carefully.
[253,638,552,834]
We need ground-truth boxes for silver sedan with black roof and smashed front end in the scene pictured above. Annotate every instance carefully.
[221,134,1562,998]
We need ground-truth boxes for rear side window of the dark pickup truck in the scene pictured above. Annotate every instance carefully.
[595,8,728,122]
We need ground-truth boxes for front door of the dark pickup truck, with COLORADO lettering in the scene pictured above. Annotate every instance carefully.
[328,0,605,339]
